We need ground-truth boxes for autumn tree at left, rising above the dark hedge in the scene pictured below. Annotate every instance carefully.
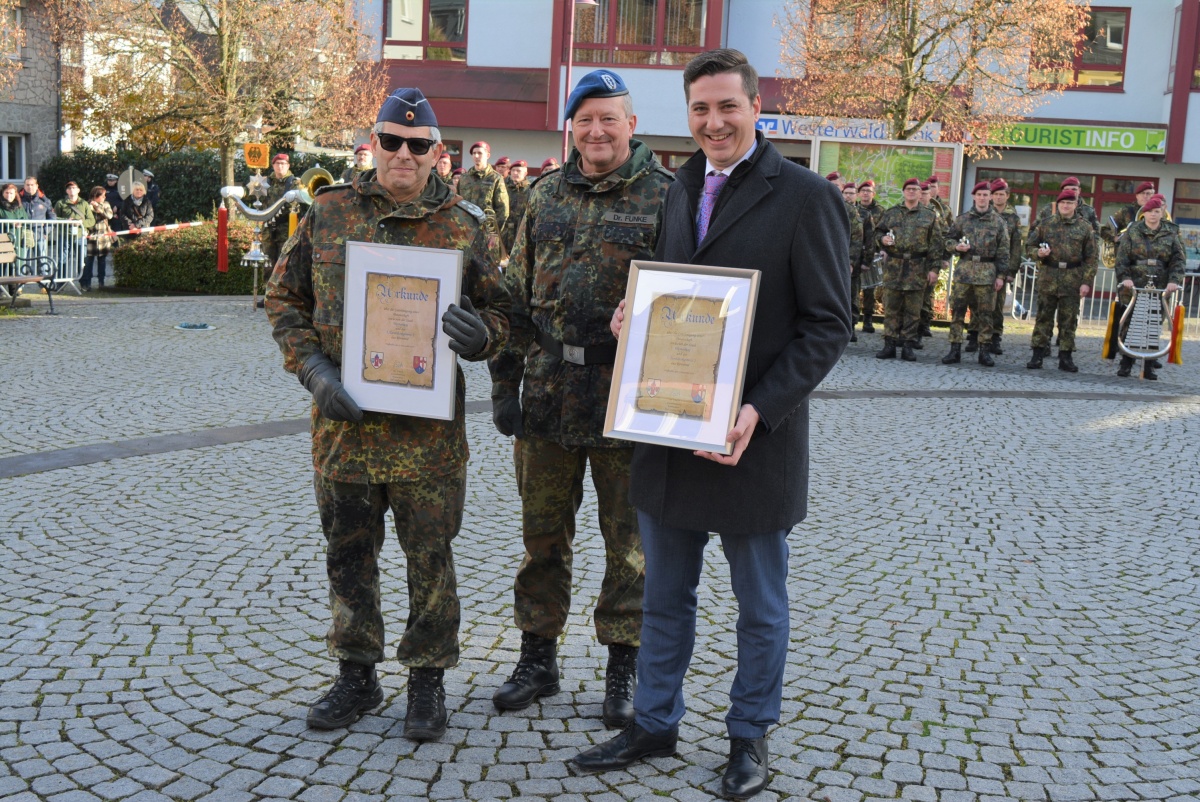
[64,0,388,184]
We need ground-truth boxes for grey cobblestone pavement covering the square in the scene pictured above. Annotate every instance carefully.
[0,297,1200,802]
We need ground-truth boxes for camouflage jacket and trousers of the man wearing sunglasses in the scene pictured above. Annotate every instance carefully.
[266,170,509,668]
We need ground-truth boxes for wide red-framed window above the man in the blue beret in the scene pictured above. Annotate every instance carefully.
[574,0,713,66]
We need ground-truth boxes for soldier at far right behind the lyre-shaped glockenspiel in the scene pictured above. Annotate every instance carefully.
[1116,198,1187,381]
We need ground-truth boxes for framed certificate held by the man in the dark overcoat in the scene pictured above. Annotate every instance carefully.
[604,261,758,454]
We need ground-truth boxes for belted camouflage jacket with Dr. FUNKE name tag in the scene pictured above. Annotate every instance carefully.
[488,139,674,448]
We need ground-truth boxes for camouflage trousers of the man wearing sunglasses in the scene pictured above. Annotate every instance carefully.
[313,466,467,669]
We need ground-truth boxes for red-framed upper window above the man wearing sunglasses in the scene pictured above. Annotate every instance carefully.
[383,0,467,61]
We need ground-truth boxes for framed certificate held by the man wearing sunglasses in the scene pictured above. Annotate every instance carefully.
[342,243,462,420]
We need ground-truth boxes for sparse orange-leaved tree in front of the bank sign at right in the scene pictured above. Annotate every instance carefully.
[778,0,1087,155]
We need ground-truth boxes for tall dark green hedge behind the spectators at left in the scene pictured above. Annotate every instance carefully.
[37,148,353,225]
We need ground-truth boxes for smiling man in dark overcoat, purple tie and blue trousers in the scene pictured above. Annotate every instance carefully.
[574,49,851,798]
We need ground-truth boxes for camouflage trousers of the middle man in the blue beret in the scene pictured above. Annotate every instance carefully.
[512,437,646,646]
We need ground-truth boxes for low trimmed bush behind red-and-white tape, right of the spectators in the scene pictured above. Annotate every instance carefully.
[113,220,272,295]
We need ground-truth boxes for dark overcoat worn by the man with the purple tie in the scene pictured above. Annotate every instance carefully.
[630,133,851,534]
